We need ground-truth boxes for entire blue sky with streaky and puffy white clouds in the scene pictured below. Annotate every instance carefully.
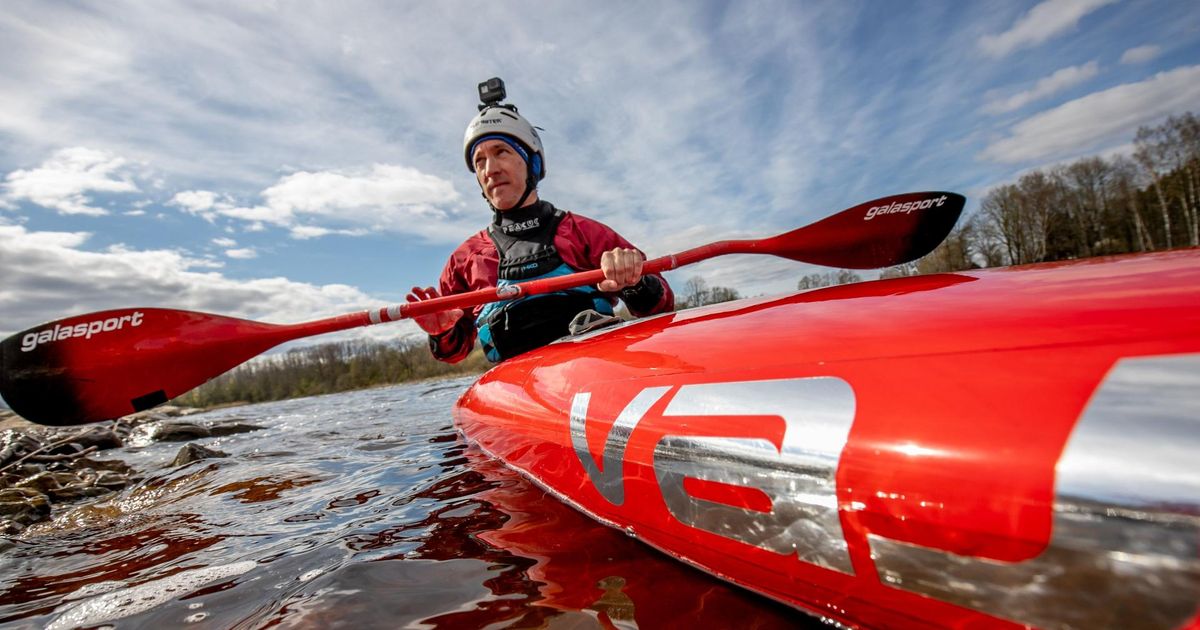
[0,0,1200,338]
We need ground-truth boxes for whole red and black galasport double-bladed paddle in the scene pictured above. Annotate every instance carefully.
[0,192,966,426]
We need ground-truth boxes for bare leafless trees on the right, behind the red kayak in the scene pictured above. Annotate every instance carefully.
[883,112,1200,277]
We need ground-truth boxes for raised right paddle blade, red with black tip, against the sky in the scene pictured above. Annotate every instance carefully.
[763,191,966,269]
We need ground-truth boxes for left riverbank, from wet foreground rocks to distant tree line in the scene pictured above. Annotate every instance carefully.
[0,342,491,535]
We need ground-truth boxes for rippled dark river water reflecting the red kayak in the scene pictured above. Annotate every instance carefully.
[0,378,820,630]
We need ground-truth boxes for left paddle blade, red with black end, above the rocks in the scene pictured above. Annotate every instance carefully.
[0,308,284,426]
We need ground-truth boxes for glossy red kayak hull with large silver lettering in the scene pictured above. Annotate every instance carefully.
[455,250,1200,628]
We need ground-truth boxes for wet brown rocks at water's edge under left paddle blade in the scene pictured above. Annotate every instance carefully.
[0,406,263,535]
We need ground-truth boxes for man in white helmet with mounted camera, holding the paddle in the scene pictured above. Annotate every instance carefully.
[407,79,674,362]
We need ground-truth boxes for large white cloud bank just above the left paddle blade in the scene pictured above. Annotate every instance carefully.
[0,226,415,337]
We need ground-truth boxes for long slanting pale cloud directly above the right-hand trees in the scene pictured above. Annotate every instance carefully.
[980,66,1200,163]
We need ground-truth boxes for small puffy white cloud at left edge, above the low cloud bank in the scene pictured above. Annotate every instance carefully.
[5,146,138,216]
